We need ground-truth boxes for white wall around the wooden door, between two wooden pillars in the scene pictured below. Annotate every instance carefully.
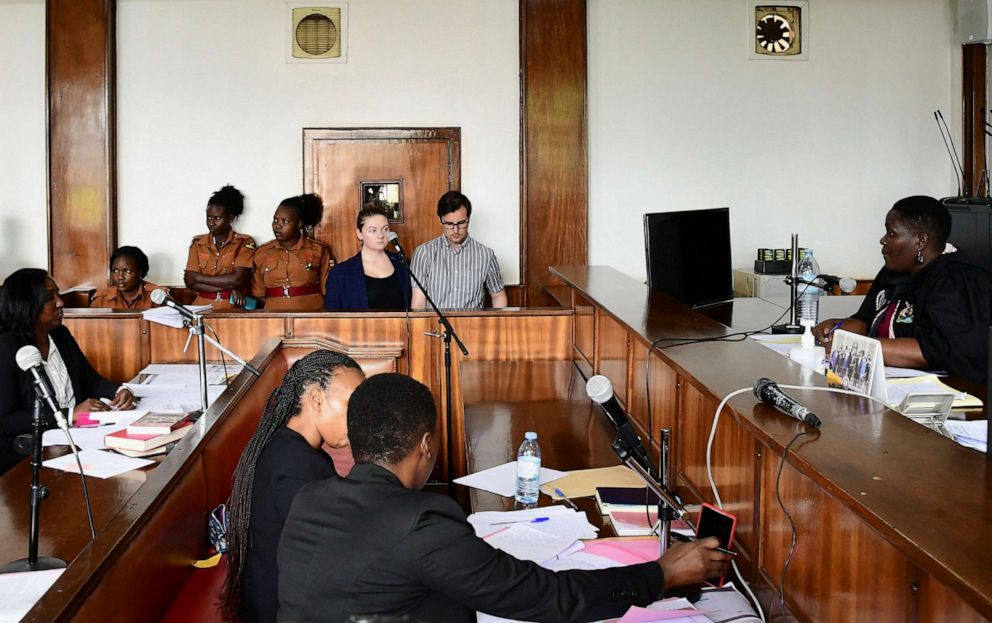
[117,0,520,284]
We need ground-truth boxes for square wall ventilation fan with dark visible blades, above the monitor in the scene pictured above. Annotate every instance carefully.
[747,0,809,61]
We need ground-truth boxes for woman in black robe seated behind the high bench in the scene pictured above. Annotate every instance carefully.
[813,196,992,382]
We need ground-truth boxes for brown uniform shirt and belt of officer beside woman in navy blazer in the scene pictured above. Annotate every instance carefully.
[251,237,334,311]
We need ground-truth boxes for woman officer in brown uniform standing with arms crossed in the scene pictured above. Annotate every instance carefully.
[183,186,255,310]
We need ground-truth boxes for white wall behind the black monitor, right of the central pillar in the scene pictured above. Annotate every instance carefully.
[588,0,961,278]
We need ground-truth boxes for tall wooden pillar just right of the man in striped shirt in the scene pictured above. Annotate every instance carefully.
[520,0,589,306]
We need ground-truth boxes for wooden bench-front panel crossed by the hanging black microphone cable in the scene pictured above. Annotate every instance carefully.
[760,448,916,623]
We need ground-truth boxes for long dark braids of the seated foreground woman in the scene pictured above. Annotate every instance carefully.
[221,350,362,621]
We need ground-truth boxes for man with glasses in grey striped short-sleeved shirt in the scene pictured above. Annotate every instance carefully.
[410,190,506,309]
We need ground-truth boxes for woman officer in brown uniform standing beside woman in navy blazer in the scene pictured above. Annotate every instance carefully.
[251,194,334,311]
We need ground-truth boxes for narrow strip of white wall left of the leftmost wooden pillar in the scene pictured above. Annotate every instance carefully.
[0,0,48,281]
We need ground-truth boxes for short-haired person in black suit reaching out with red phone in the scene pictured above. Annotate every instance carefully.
[279,374,729,622]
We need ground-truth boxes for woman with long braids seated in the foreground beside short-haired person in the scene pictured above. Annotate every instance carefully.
[221,350,365,623]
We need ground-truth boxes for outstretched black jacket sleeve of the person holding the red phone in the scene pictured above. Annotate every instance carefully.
[396,502,665,622]
